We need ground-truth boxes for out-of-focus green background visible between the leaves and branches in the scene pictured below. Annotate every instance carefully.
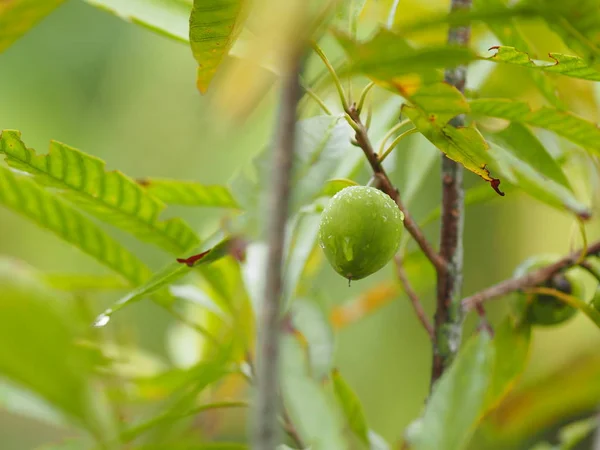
[0,1,600,450]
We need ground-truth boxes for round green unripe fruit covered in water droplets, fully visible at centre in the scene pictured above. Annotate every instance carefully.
[319,186,404,280]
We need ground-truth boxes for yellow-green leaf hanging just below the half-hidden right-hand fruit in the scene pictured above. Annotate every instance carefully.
[485,318,531,410]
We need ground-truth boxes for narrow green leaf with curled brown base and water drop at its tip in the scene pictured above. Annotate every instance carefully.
[95,238,232,326]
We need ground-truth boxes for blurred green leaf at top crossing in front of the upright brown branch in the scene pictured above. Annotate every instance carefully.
[335,29,477,81]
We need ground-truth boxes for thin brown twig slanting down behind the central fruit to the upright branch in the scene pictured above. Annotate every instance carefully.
[346,104,445,271]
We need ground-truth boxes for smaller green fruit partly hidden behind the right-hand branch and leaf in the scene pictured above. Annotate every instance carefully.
[514,255,584,326]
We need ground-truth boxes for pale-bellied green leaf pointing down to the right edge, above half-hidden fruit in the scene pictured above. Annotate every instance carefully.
[490,138,591,219]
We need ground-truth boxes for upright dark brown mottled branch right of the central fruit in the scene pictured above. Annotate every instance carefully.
[431,0,471,386]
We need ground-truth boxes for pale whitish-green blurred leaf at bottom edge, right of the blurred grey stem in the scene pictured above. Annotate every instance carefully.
[281,334,347,450]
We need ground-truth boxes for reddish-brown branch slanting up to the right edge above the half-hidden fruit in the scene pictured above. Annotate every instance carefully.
[461,241,600,311]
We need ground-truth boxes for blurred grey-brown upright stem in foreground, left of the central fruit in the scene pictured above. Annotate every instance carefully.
[254,54,302,450]
